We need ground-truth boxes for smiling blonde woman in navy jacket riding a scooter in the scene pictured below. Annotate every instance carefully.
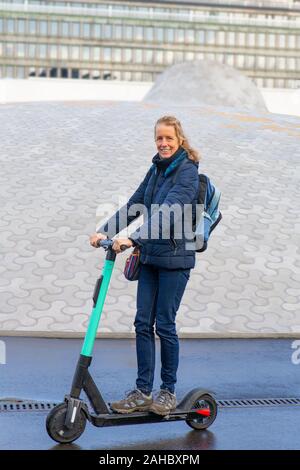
[90,116,199,415]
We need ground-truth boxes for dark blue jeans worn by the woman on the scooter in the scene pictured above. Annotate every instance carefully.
[134,264,190,394]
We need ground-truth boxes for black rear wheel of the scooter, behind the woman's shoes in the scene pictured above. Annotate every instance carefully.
[185,394,218,430]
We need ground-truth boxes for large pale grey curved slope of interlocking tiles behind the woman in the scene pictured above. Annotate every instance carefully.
[0,101,300,336]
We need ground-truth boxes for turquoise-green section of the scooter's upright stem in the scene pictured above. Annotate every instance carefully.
[81,259,115,357]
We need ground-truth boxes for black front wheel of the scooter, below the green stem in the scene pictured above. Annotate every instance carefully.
[46,403,86,444]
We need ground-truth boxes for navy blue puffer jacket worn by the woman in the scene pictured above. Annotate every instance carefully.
[97,147,199,269]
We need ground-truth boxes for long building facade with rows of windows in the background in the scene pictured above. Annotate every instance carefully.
[0,0,300,88]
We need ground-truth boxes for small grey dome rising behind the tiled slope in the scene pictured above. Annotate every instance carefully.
[144,60,267,112]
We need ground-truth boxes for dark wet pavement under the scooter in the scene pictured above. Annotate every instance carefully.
[0,337,300,450]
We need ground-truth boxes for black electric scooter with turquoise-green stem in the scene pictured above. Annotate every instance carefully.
[46,240,217,444]
